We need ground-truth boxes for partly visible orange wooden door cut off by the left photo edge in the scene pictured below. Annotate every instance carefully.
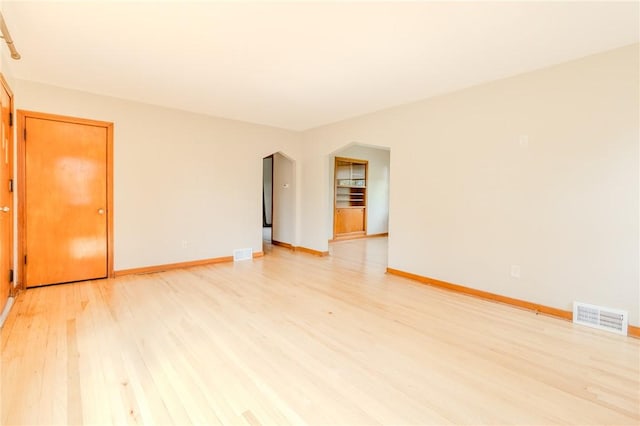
[0,77,13,312]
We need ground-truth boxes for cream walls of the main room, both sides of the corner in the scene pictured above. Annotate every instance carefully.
[3,45,640,325]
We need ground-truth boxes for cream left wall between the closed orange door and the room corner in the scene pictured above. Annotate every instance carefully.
[13,80,300,270]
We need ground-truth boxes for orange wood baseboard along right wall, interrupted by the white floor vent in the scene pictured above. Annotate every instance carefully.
[387,268,640,338]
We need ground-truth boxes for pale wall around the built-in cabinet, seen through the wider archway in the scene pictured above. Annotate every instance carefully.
[327,144,389,239]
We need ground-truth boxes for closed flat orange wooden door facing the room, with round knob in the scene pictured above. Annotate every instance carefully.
[22,113,111,287]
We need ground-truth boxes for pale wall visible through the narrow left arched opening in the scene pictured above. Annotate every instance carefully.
[271,152,296,245]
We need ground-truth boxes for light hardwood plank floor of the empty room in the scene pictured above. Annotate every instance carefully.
[0,238,640,425]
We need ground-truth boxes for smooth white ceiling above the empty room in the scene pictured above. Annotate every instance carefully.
[0,0,640,130]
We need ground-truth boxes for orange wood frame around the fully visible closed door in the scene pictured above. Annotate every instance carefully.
[17,110,114,290]
